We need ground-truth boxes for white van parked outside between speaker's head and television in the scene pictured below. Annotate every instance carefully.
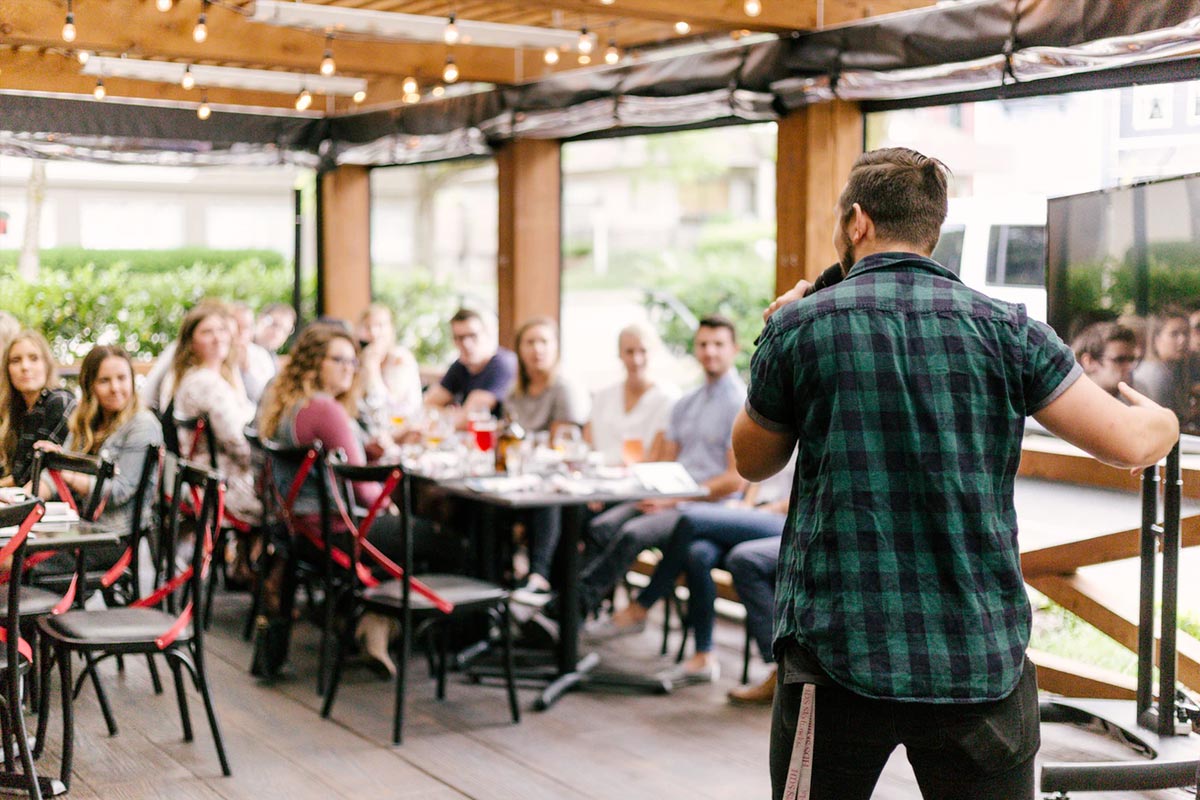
[934,197,1046,321]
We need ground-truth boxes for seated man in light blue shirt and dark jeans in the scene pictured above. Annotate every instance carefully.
[580,315,746,614]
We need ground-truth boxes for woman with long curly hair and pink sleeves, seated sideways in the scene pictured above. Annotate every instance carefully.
[258,323,428,675]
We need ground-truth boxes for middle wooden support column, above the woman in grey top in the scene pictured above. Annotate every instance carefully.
[496,139,563,348]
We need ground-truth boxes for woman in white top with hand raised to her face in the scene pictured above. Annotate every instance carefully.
[358,302,421,433]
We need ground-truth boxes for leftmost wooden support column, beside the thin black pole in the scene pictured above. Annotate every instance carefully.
[317,167,371,321]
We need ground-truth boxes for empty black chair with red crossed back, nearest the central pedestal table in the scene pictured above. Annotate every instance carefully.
[320,462,521,745]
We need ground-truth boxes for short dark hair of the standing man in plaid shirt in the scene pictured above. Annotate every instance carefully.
[838,148,949,252]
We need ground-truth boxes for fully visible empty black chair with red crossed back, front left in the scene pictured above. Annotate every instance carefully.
[36,461,230,787]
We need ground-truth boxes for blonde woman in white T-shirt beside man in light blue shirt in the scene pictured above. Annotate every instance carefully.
[583,325,679,464]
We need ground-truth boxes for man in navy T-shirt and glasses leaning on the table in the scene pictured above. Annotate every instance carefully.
[425,308,517,420]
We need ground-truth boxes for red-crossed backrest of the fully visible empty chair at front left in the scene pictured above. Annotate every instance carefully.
[160,459,224,637]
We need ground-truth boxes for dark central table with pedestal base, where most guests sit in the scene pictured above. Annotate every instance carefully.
[409,470,704,711]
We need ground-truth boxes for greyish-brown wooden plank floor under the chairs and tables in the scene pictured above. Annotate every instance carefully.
[21,587,1195,800]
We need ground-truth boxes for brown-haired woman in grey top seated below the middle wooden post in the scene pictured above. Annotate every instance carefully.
[504,317,587,604]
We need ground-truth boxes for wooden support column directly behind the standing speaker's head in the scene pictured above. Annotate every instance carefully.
[775,101,863,294]
